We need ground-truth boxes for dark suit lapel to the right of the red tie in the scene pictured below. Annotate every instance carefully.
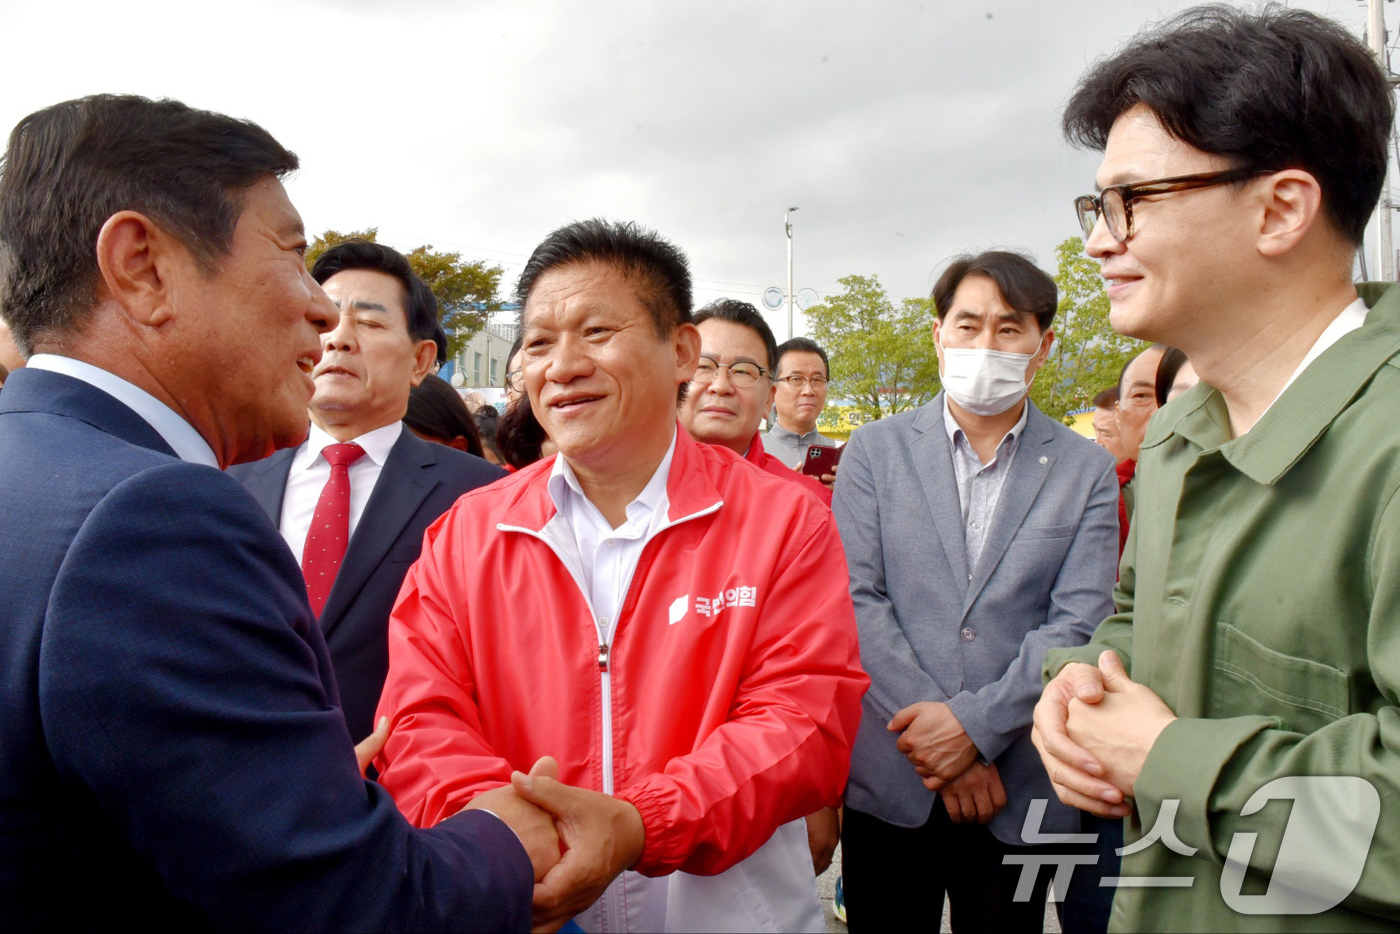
[321,427,438,636]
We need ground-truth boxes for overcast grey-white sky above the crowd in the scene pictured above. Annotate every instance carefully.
[0,0,1383,339]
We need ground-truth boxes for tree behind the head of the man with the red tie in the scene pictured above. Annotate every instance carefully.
[307,227,504,357]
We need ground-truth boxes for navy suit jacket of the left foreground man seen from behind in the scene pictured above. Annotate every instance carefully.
[0,370,533,930]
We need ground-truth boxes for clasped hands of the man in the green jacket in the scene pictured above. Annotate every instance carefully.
[1030,651,1176,818]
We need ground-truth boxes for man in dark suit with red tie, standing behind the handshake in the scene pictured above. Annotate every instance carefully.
[230,241,505,739]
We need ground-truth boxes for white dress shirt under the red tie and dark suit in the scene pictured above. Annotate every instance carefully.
[277,421,403,564]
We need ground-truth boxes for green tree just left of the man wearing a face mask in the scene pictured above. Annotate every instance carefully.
[806,276,938,421]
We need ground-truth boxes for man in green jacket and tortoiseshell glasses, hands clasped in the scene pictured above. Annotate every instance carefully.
[1033,8,1400,931]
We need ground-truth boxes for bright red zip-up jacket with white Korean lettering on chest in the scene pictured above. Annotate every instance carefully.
[378,430,869,875]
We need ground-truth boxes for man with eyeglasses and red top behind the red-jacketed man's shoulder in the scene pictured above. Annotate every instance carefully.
[680,298,832,506]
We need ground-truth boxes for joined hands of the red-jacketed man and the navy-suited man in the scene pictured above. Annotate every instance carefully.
[466,756,645,931]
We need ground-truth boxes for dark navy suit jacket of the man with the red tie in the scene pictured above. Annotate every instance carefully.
[228,426,505,741]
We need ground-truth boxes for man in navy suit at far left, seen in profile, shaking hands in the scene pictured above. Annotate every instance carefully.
[0,95,567,930]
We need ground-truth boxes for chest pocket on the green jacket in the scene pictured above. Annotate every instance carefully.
[1207,622,1351,734]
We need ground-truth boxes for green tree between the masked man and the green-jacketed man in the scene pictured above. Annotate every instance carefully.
[1030,237,1147,421]
